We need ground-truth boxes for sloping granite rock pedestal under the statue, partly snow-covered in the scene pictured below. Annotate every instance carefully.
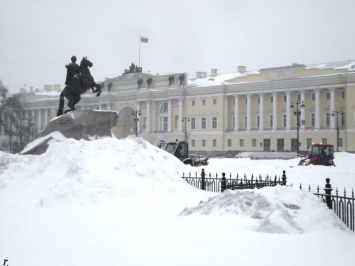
[21,110,118,154]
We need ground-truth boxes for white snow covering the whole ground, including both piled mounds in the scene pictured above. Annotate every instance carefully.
[0,137,355,266]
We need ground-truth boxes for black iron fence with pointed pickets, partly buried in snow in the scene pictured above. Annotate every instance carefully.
[182,169,355,231]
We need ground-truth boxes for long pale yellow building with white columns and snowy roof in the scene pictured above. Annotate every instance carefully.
[18,61,355,154]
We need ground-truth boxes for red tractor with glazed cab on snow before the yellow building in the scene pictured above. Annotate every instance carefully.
[298,143,335,166]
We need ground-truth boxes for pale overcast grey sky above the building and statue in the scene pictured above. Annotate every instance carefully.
[0,0,355,92]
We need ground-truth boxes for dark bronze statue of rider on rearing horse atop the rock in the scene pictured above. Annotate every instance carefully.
[57,56,101,116]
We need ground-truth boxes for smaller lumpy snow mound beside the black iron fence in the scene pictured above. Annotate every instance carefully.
[180,186,345,234]
